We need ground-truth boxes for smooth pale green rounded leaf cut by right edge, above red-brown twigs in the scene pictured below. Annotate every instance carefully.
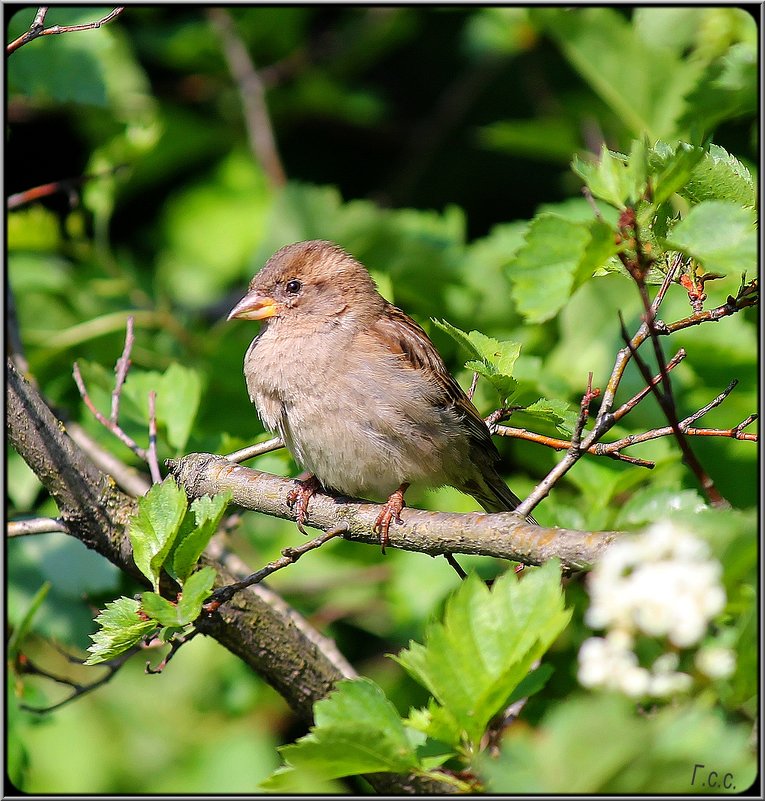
[667,200,757,273]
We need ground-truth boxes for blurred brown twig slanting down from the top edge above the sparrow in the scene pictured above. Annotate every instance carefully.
[207,8,287,188]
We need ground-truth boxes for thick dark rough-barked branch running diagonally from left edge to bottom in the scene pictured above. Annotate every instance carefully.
[6,360,453,795]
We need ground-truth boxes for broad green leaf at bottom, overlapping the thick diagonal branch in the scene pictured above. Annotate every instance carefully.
[262,679,418,789]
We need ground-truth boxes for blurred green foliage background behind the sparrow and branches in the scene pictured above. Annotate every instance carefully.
[4,6,759,794]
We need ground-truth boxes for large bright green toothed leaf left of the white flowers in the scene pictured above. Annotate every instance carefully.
[394,560,571,748]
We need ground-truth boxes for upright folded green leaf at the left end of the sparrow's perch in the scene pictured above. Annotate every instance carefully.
[128,477,187,590]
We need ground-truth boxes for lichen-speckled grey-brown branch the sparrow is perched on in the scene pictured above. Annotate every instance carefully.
[167,453,618,569]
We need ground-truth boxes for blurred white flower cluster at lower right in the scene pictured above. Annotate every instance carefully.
[579,522,735,698]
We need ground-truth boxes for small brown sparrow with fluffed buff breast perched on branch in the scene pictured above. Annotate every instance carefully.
[228,240,536,553]
